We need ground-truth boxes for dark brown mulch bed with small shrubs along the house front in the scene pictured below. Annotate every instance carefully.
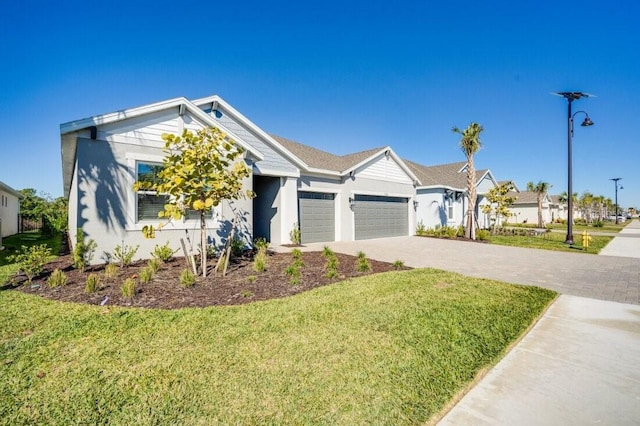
[16,252,406,309]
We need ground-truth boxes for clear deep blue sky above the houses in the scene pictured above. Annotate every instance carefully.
[0,0,640,207]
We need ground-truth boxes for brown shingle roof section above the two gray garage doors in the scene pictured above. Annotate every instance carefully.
[270,135,385,172]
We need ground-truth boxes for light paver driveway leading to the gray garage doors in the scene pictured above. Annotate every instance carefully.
[292,237,640,304]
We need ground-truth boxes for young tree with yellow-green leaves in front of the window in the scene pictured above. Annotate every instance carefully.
[133,127,253,277]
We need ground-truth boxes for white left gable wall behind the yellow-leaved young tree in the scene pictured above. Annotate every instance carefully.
[69,110,253,263]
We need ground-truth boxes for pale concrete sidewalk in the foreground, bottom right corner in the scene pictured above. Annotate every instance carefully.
[438,296,640,426]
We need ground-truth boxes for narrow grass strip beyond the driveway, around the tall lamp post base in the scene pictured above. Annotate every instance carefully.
[489,228,613,254]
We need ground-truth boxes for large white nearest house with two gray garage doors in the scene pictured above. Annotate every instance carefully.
[60,96,420,263]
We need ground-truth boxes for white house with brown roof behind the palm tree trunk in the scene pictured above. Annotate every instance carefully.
[405,160,497,228]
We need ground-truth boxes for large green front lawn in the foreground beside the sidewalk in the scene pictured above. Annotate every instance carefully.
[0,269,555,425]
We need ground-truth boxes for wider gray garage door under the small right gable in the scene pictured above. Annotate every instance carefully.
[353,195,409,240]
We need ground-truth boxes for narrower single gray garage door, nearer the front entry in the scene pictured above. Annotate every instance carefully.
[298,192,336,244]
